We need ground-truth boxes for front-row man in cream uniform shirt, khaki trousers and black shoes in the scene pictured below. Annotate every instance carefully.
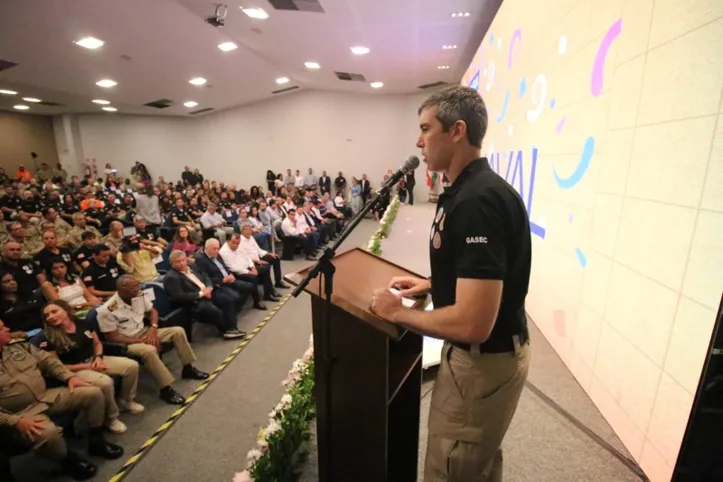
[98,275,209,405]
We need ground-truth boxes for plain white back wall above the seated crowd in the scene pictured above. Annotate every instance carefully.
[79,91,429,191]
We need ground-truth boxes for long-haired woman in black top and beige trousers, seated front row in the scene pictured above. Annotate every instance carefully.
[43,300,144,433]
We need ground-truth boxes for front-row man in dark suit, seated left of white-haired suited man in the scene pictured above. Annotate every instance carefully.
[163,250,248,340]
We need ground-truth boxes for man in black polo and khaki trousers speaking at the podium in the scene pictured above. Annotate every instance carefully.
[371,86,531,482]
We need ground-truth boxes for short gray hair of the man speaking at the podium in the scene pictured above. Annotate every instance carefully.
[417,85,487,149]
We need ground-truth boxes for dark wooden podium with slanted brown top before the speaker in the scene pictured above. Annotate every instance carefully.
[286,248,423,482]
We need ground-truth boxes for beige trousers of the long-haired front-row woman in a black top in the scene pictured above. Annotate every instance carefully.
[76,356,138,422]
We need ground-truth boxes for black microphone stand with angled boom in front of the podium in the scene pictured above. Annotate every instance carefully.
[291,186,389,474]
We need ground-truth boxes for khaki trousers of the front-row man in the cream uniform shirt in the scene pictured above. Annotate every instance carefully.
[128,326,196,388]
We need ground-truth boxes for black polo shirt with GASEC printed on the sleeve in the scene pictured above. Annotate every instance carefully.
[429,158,532,347]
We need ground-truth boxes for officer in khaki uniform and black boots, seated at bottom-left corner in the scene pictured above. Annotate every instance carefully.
[0,321,123,481]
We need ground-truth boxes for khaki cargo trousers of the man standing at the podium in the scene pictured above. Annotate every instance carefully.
[424,337,530,482]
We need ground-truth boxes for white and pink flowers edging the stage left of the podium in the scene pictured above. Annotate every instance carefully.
[233,335,314,482]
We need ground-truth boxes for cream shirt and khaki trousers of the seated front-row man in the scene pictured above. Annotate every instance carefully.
[98,293,196,388]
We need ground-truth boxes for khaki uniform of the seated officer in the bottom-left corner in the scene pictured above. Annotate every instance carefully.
[0,340,105,461]
